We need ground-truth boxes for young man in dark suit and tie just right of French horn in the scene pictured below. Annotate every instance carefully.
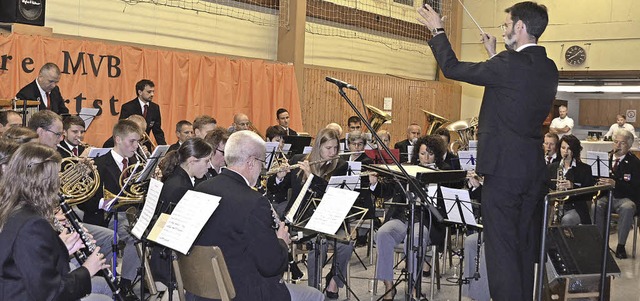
[78,119,142,300]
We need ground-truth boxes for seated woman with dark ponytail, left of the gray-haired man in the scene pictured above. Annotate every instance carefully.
[151,138,212,286]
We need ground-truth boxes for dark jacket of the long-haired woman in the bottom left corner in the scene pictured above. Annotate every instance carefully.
[0,208,91,301]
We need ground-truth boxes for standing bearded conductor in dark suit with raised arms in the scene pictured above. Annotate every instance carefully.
[418,2,558,301]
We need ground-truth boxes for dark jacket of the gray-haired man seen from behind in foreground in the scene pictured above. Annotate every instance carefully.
[195,169,291,301]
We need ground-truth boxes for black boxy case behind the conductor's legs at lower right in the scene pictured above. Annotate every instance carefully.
[547,225,620,277]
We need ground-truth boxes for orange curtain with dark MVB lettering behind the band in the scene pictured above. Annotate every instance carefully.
[0,34,303,146]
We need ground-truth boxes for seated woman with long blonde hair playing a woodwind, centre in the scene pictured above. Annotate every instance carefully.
[267,128,353,299]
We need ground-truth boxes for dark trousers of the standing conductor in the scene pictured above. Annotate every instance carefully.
[482,171,544,301]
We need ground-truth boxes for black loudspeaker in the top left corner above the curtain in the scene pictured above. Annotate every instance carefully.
[0,0,46,26]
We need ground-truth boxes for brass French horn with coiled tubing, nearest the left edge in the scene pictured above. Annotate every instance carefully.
[59,157,100,206]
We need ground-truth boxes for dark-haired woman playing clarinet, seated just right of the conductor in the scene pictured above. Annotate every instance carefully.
[546,135,596,226]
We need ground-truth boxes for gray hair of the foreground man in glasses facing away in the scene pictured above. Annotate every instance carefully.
[224,131,266,167]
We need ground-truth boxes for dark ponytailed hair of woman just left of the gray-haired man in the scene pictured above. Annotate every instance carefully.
[160,138,212,181]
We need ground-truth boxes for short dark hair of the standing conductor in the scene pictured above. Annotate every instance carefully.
[504,1,549,42]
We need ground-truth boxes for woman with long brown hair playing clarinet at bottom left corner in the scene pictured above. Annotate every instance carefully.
[0,143,108,301]
